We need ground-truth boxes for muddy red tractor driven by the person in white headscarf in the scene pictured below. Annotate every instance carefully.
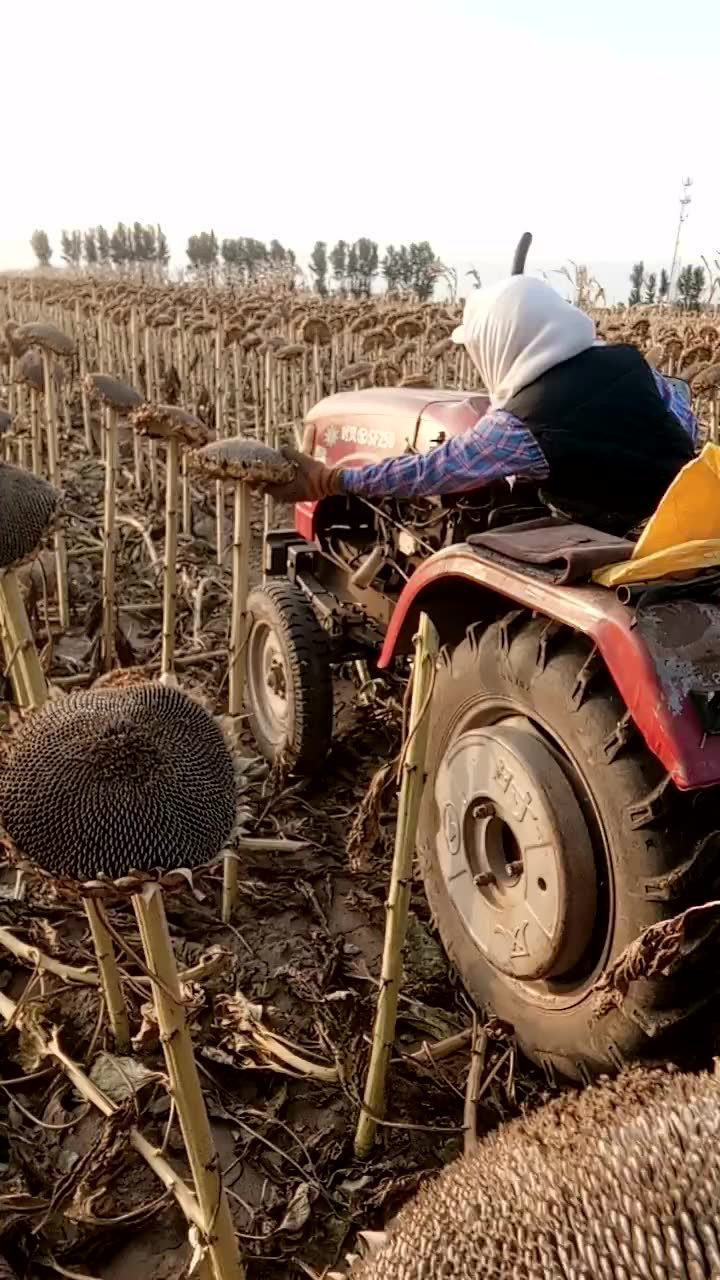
[247,238,720,1079]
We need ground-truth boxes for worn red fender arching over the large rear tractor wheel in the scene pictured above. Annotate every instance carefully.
[378,547,720,790]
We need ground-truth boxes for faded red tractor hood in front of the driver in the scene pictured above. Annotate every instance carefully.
[305,387,489,476]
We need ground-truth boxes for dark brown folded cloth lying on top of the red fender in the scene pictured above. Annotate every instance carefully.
[468,516,635,585]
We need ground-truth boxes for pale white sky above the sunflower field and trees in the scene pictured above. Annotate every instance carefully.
[0,0,720,298]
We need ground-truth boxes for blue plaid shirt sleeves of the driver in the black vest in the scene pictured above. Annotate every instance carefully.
[343,370,697,498]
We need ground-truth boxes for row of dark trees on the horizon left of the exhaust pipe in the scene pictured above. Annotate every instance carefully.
[31,221,448,302]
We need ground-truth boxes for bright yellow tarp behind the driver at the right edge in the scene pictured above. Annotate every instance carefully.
[593,444,720,586]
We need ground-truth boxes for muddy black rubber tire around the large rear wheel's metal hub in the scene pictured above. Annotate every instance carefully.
[418,611,719,1079]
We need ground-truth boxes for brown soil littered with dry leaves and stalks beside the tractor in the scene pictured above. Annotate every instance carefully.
[0,432,548,1280]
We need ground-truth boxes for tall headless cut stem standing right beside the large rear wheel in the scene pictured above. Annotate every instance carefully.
[355,613,438,1160]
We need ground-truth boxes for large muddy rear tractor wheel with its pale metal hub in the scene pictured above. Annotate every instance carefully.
[418,612,719,1079]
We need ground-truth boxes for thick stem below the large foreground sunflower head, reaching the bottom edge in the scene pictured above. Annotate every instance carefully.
[132,884,245,1280]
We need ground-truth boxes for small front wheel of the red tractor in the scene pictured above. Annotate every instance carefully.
[246,581,333,772]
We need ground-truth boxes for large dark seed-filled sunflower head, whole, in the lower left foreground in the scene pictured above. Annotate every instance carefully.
[0,682,237,883]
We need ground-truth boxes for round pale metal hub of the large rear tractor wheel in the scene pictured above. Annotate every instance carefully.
[436,717,597,980]
